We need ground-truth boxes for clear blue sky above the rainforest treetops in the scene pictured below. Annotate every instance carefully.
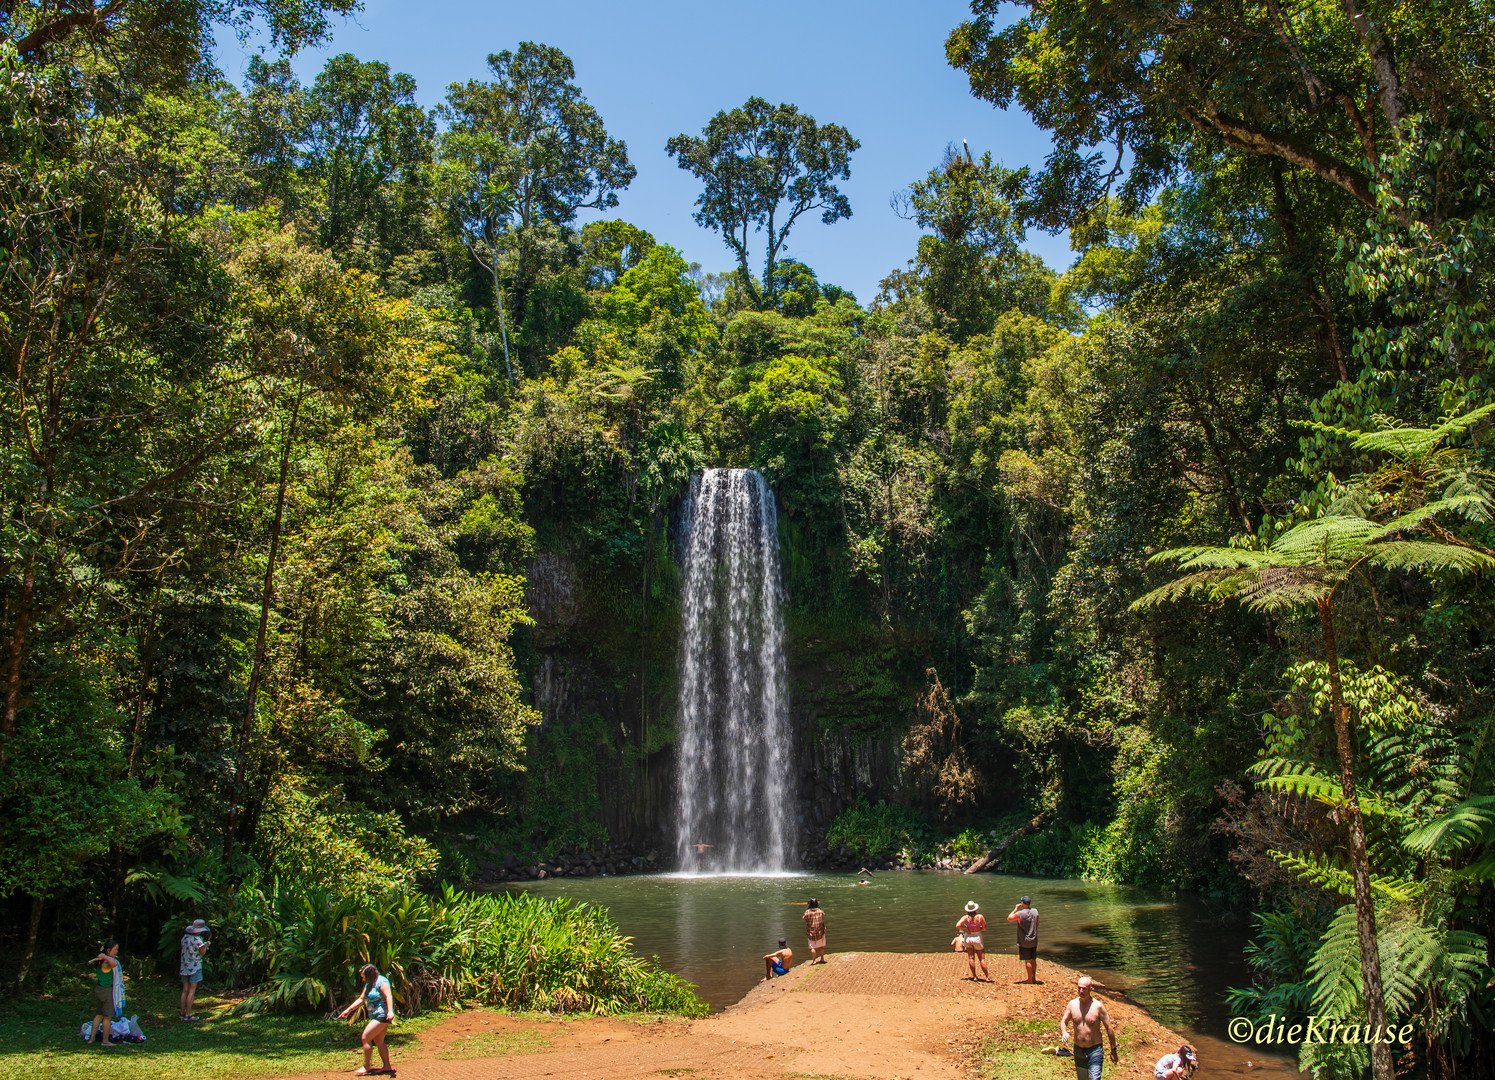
[218,0,1072,304]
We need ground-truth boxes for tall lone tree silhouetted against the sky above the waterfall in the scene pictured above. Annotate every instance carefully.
[665,97,861,308]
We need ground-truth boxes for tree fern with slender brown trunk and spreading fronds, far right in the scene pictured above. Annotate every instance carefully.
[1132,405,1495,1080]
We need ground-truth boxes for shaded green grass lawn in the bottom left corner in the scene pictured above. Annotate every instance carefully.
[0,978,447,1080]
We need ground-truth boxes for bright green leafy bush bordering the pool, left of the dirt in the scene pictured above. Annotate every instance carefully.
[241,887,706,1016]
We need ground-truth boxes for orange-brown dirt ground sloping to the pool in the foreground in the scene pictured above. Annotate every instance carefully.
[275,953,1181,1080]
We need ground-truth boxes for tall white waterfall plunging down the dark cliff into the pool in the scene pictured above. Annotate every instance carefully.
[676,468,789,872]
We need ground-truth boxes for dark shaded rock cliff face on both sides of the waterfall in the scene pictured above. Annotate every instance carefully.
[520,487,898,866]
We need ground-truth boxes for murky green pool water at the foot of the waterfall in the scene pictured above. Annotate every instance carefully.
[510,871,1296,1080]
